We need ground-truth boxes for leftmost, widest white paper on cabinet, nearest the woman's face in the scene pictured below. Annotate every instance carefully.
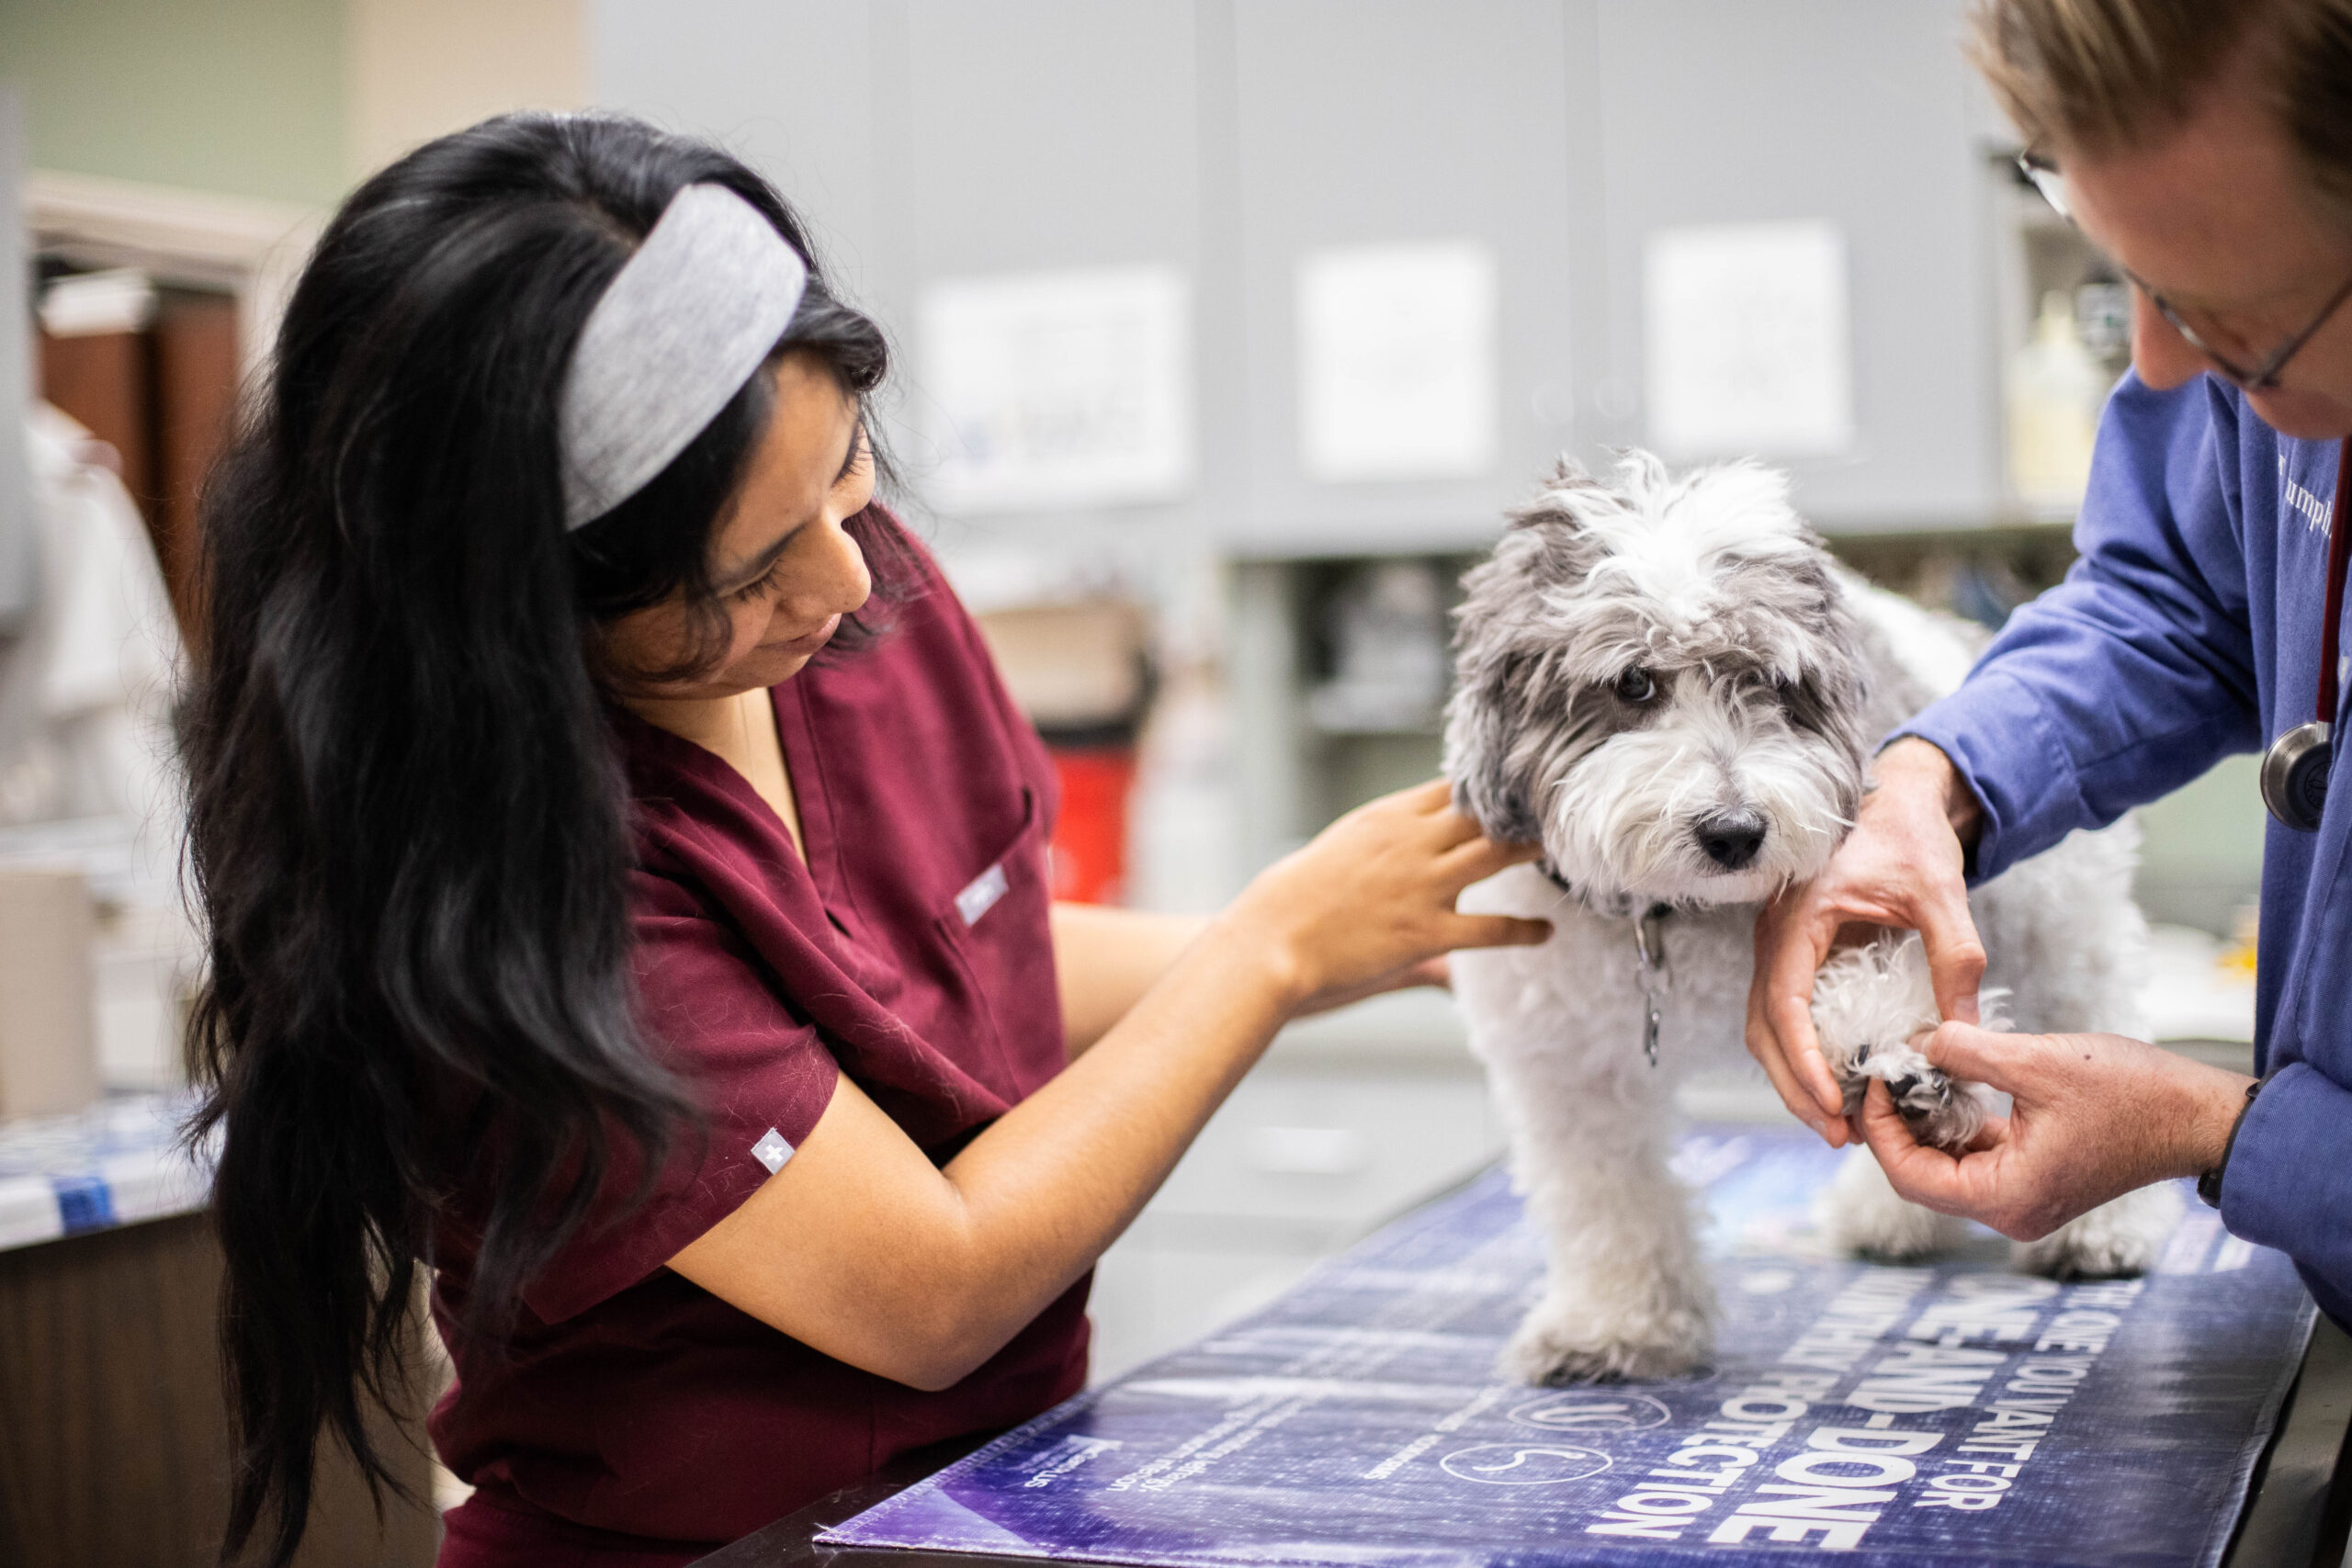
[917,265,1193,514]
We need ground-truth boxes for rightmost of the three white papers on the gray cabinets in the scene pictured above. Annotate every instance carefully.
[1642,223,1853,458]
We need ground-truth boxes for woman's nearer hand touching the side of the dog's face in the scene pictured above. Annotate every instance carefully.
[1221,781,1553,1016]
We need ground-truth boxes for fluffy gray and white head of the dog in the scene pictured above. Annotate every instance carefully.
[1446,451,1865,908]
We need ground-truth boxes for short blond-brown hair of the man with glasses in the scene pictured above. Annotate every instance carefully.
[1969,0,2352,211]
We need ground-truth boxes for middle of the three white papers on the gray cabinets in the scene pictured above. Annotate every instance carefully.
[1298,243,1496,482]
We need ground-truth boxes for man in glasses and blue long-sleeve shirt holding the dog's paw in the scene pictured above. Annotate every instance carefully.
[1747,0,2352,1324]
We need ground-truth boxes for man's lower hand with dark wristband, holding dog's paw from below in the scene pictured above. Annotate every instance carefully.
[1853,1022,2248,1241]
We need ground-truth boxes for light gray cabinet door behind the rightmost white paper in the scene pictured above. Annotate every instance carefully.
[1592,0,1999,526]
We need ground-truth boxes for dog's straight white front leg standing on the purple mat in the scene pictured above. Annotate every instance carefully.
[1498,1046,1714,1382]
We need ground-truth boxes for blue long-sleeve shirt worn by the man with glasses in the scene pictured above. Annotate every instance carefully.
[1895,376,2352,1324]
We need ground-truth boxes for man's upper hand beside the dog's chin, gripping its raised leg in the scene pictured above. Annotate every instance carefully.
[1747,740,1985,1147]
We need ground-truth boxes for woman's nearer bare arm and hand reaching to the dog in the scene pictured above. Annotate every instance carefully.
[671,783,1547,1389]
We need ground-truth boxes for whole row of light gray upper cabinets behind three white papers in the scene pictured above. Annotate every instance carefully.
[591,0,1999,558]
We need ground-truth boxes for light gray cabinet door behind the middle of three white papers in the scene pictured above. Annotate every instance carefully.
[1211,0,1597,555]
